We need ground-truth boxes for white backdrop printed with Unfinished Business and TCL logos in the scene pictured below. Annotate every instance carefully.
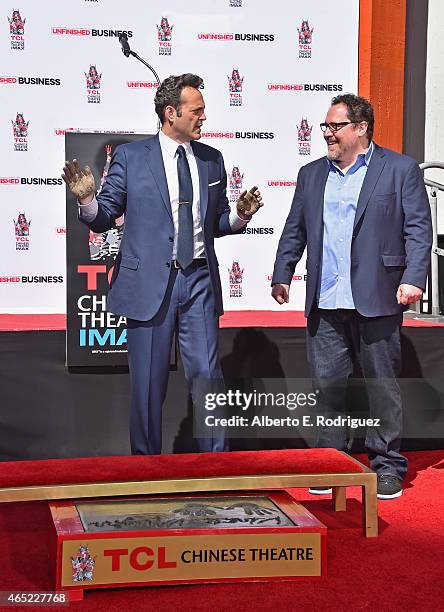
[0,0,359,313]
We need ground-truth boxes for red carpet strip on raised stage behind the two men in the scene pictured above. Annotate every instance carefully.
[0,310,444,331]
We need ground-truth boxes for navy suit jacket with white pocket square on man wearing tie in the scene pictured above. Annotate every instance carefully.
[89,135,239,321]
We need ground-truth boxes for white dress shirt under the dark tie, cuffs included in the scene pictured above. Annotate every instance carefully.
[79,130,248,259]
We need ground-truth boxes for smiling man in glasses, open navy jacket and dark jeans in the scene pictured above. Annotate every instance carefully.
[272,94,432,499]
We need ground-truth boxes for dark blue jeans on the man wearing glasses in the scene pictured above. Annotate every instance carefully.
[307,308,407,478]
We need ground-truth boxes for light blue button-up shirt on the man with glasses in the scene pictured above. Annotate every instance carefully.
[319,143,373,309]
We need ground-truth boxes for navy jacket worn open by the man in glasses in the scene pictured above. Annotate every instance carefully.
[272,144,432,317]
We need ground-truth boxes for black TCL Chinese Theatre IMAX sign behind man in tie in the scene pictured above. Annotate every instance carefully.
[65,132,150,366]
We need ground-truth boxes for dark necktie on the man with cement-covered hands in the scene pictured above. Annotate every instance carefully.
[176,145,194,270]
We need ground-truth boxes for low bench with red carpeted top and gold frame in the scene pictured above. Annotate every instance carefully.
[0,448,378,537]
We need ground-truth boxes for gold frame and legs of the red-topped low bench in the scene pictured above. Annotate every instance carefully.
[0,456,378,538]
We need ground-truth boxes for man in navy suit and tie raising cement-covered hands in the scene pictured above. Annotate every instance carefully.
[63,74,263,454]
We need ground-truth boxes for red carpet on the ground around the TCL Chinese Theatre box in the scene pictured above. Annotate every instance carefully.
[0,451,444,612]
